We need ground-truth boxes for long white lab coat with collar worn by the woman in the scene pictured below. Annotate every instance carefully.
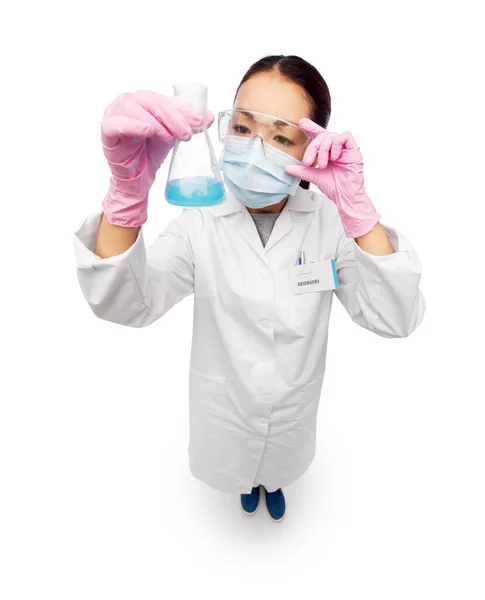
[74,187,425,493]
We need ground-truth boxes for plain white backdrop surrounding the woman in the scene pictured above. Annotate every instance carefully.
[0,0,485,600]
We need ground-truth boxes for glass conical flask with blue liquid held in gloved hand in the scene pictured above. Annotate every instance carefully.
[165,83,225,206]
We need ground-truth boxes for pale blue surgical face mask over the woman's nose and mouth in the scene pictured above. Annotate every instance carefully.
[219,135,303,208]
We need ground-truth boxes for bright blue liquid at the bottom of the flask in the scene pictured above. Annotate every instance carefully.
[165,177,225,206]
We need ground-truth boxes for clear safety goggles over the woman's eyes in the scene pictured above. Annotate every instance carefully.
[218,108,312,159]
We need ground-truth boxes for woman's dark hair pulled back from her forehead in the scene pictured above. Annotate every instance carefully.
[234,54,331,189]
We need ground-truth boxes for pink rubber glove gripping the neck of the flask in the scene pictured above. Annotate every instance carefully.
[101,90,214,227]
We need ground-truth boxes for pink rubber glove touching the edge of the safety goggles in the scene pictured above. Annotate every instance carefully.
[286,119,380,238]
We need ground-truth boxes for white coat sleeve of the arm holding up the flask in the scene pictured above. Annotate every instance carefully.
[74,211,194,327]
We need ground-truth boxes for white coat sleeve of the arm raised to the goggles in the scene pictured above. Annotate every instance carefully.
[334,225,426,338]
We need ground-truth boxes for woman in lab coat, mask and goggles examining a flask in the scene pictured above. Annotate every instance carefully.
[74,56,425,521]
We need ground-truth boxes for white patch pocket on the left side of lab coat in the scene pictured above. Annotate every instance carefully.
[189,369,228,457]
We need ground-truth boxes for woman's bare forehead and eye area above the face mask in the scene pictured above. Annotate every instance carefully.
[231,73,311,160]
